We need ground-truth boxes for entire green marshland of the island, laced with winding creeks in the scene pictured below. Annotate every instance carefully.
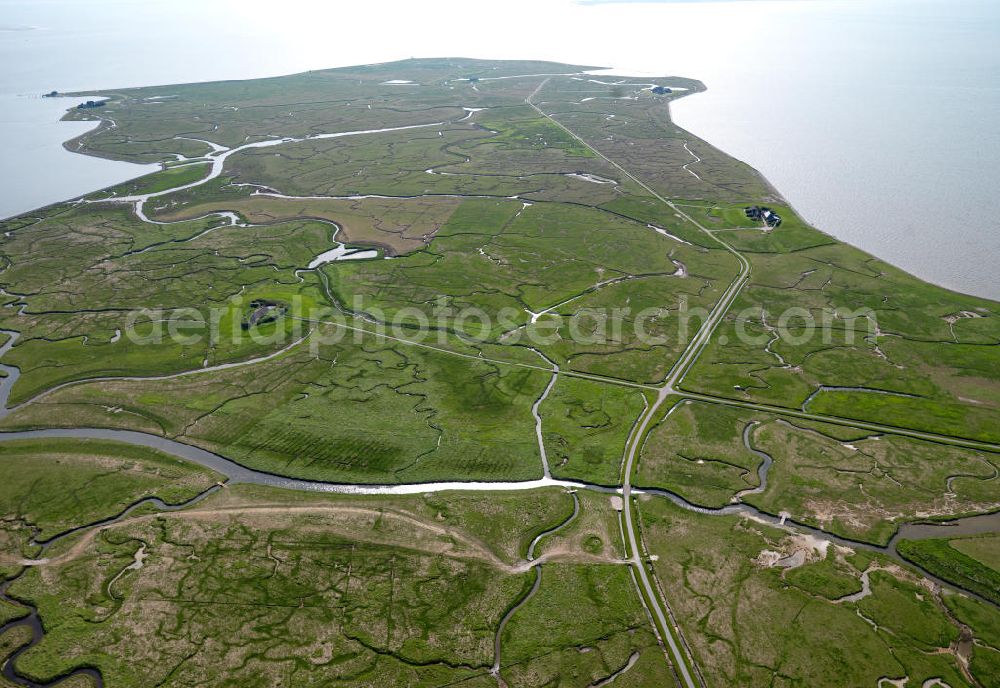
[0,58,1000,688]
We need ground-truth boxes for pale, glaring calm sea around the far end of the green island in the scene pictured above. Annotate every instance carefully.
[0,0,1000,298]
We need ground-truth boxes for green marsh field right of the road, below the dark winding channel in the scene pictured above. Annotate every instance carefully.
[639,499,997,686]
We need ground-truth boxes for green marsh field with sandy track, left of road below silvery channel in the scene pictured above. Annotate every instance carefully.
[3,486,640,686]
